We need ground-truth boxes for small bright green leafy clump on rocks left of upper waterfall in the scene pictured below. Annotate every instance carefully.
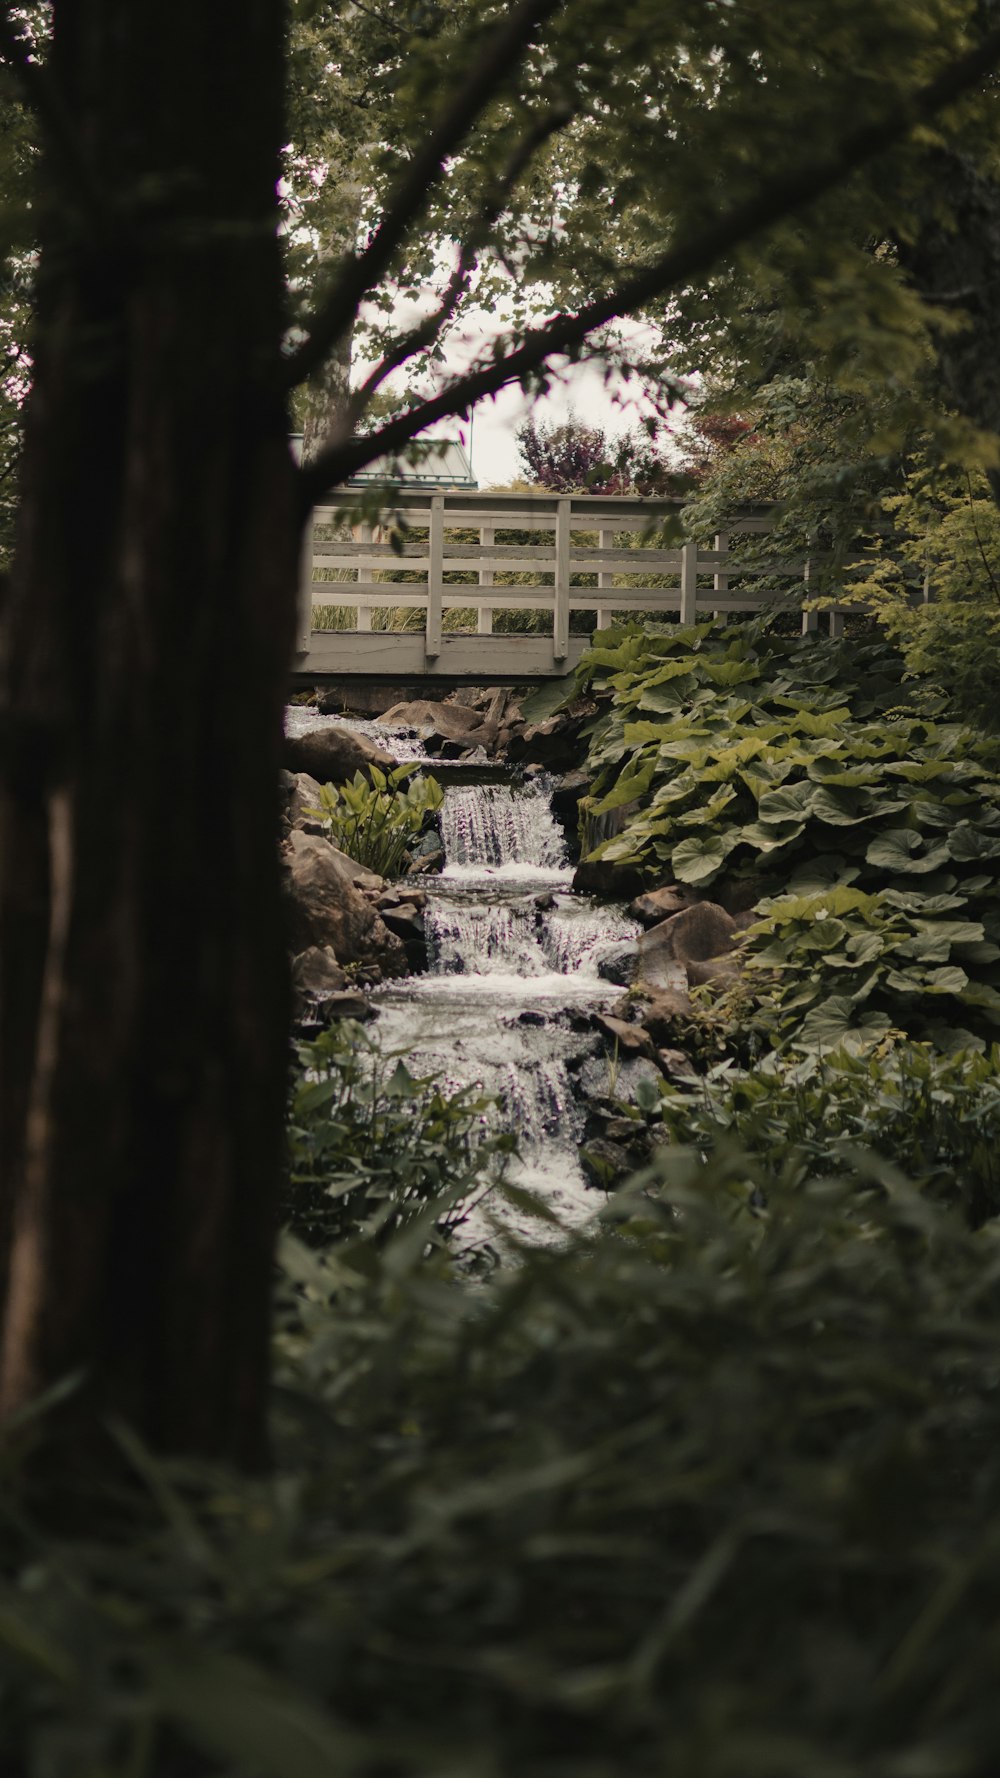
[308,763,445,877]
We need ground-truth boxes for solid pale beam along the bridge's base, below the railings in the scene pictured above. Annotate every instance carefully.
[294,629,591,675]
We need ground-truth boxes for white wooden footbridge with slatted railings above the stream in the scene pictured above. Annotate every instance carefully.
[295,489,847,683]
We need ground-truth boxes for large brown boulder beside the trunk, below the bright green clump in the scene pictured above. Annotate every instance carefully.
[286,830,407,976]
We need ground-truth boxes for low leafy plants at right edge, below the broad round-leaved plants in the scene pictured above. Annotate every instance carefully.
[653,1042,1000,1227]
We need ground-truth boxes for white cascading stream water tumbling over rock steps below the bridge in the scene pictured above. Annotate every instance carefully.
[290,711,639,1243]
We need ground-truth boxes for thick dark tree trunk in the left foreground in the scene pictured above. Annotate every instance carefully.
[0,0,297,1463]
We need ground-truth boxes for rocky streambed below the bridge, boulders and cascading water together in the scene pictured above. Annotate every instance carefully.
[281,688,753,1214]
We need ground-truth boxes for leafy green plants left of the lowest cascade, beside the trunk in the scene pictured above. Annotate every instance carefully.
[283,1021,512,1246]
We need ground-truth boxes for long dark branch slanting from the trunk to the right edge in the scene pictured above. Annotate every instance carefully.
[299,28,1000,512]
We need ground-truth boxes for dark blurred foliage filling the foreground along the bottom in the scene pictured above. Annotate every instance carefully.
[9,1149,1000,1778]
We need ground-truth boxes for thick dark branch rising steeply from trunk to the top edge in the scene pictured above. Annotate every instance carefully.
[283,0,564,389]
